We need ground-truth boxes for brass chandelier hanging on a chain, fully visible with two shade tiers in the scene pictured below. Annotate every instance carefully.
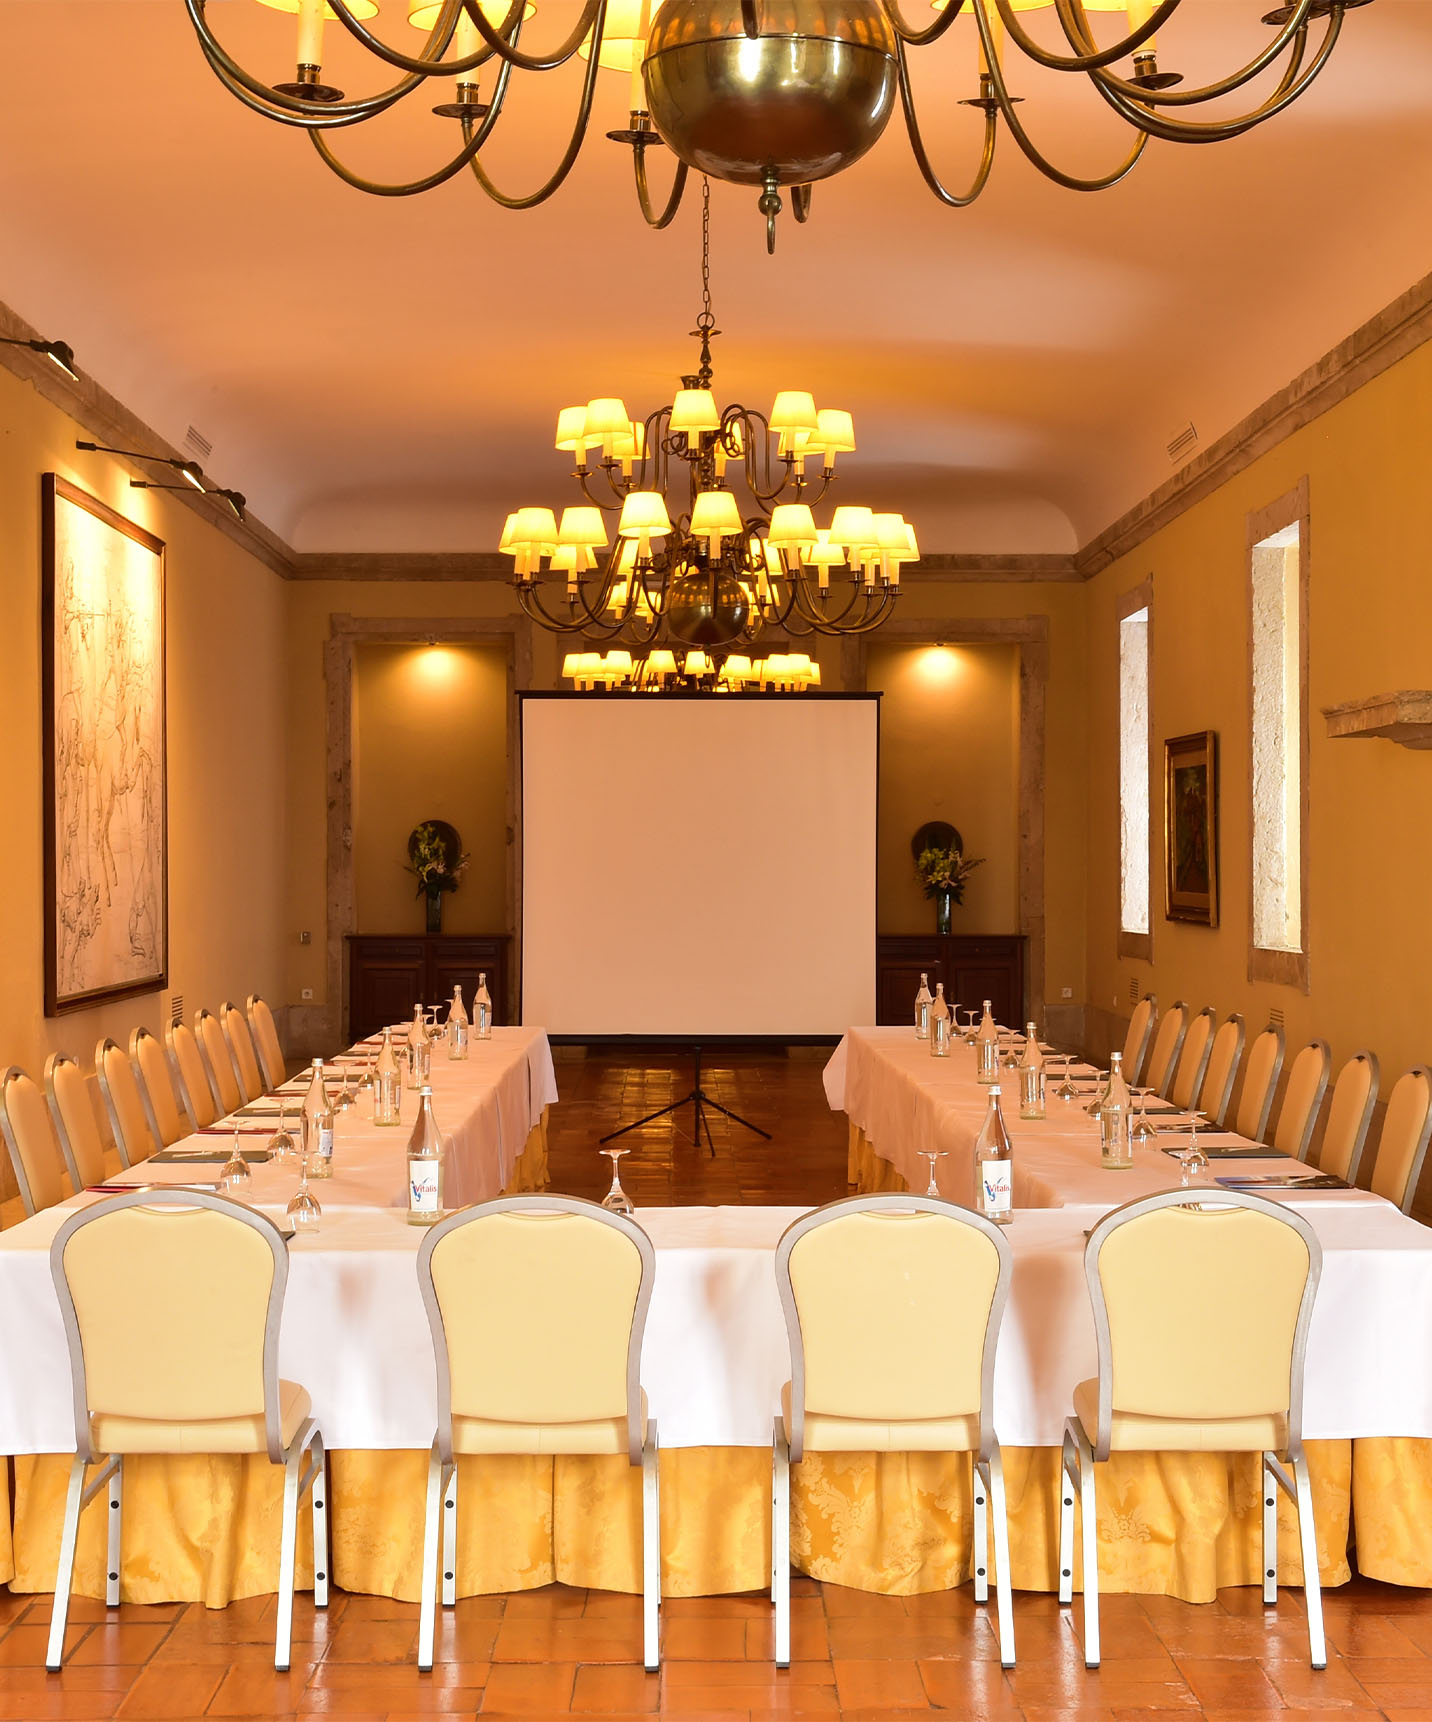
[499,181,919,650]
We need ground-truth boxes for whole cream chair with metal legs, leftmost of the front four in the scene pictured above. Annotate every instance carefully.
[45,1188,329,1669]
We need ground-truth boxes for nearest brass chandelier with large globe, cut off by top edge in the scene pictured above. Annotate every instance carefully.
[184,0,1368,248]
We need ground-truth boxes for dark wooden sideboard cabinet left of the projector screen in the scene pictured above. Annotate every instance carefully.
[348,933,513,1040]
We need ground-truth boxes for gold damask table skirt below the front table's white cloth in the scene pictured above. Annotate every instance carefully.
[12,1440,1432,1607]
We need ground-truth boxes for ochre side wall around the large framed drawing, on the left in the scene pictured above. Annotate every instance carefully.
[0,370,287,1193]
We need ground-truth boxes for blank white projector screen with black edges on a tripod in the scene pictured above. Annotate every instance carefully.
[522,694,880,1040]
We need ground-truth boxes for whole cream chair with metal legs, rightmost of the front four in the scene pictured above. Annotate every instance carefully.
[1059,1190,1327,1669]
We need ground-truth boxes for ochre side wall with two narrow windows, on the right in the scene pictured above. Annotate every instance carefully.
[1088,346,1432,1188]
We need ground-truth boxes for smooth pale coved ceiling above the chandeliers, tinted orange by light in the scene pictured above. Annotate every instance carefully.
[0,0,1432,553]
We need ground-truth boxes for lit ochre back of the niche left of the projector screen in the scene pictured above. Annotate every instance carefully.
[353,644,508,933]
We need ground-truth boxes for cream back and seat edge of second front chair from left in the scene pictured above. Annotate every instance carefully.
[418,1195,656,1464]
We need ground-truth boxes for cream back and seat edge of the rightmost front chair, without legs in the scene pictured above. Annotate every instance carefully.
[1084,1190,1322,1457]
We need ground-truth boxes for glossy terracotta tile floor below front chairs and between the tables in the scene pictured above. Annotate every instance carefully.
[0,1050,1432,1722]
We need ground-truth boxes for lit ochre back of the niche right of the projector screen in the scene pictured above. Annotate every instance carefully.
[866,644,1019,933]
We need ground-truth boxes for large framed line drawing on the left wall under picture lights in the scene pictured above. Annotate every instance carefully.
[40,472,169,1016]
